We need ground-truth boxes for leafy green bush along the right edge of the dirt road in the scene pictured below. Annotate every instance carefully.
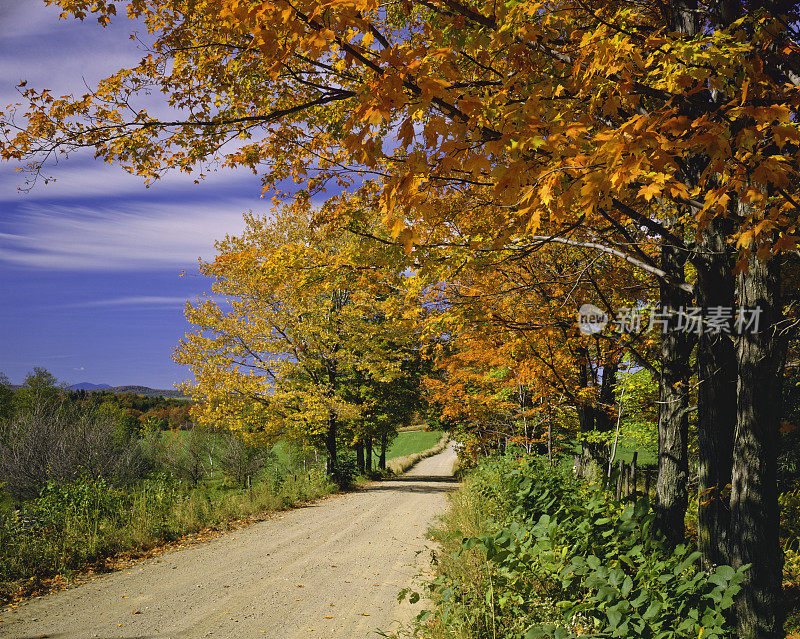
[418,457,743,639]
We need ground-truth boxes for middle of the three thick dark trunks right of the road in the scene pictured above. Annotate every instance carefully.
[696,220,736,567]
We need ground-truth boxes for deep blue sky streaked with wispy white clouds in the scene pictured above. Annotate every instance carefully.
[0,0,268,388]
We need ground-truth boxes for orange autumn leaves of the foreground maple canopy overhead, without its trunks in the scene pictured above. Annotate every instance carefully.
[0,0,800,444]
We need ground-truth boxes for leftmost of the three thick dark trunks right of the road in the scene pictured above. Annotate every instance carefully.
[654,232,695,546]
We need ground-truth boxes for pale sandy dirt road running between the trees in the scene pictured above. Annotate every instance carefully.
[0,447,455,639]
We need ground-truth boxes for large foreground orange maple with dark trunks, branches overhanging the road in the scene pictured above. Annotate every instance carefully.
[0,0,800,637]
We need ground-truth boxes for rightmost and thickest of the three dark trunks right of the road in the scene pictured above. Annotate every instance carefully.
[730,257,785,639]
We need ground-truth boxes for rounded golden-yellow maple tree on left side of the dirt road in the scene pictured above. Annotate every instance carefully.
[175,208,413,475]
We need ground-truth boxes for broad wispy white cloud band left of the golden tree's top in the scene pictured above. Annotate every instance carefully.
[0,198,258,271]
